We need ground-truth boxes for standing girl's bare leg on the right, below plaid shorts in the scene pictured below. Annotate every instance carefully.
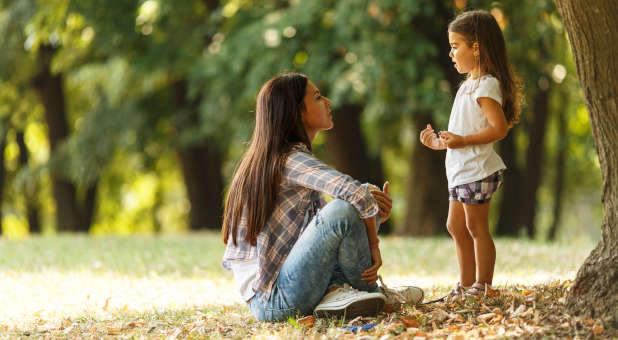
[463,202,496,285]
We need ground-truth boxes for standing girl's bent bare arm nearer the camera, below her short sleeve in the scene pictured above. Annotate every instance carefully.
[440,97,509,149]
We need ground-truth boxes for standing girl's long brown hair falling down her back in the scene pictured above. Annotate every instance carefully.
[448,10,522,126]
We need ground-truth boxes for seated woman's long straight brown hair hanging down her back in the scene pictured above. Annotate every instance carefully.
[222,73,311,246]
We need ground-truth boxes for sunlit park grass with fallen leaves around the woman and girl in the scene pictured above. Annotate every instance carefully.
[0,233,602,339]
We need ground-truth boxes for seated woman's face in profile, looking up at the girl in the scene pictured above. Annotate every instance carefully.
[301,80,334,142]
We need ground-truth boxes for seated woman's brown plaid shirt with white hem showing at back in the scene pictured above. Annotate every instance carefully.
[223,144,378,300]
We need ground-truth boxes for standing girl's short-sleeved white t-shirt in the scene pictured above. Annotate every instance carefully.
[445,75,506,188]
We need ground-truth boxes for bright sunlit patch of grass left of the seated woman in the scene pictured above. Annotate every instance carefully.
[0,270,240,328]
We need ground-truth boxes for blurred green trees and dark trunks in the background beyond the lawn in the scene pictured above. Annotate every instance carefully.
[0,0,602,241]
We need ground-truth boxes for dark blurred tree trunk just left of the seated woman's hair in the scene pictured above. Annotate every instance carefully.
[173,80,223,230]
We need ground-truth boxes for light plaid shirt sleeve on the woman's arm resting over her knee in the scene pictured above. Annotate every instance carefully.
[284,152,378,219]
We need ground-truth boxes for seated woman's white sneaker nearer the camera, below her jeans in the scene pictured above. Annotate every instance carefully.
[313,283,386,318]
